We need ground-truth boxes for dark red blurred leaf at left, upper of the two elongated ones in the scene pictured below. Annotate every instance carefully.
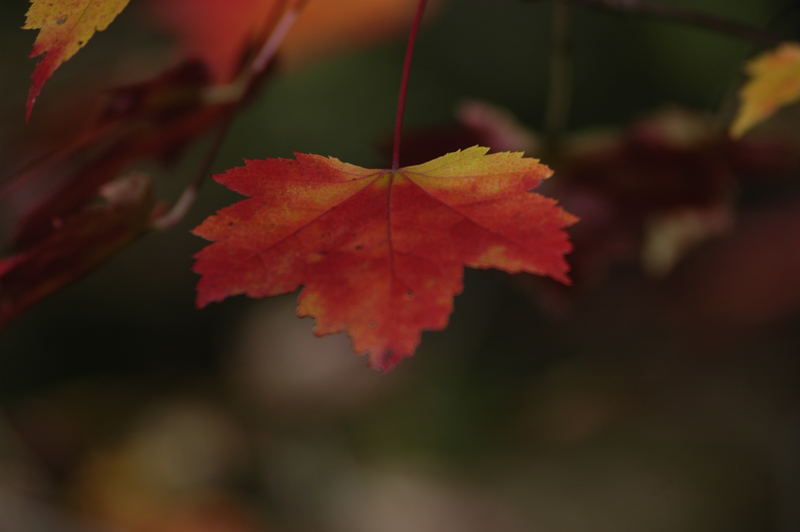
[7,62,225,248]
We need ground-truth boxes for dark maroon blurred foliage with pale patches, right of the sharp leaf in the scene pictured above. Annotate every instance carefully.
[557,108,797,284]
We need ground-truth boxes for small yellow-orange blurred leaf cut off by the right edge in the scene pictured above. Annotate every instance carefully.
[731,42,800,138]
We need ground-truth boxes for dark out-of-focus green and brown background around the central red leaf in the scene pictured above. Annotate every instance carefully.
[0,0,800,532]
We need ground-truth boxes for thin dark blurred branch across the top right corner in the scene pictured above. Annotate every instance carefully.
[571,0,784,45]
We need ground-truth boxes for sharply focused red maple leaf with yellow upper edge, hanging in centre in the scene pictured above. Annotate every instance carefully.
[194,146,577,370]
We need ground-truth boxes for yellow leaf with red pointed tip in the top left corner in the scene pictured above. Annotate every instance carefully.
[23,0,129,118]
